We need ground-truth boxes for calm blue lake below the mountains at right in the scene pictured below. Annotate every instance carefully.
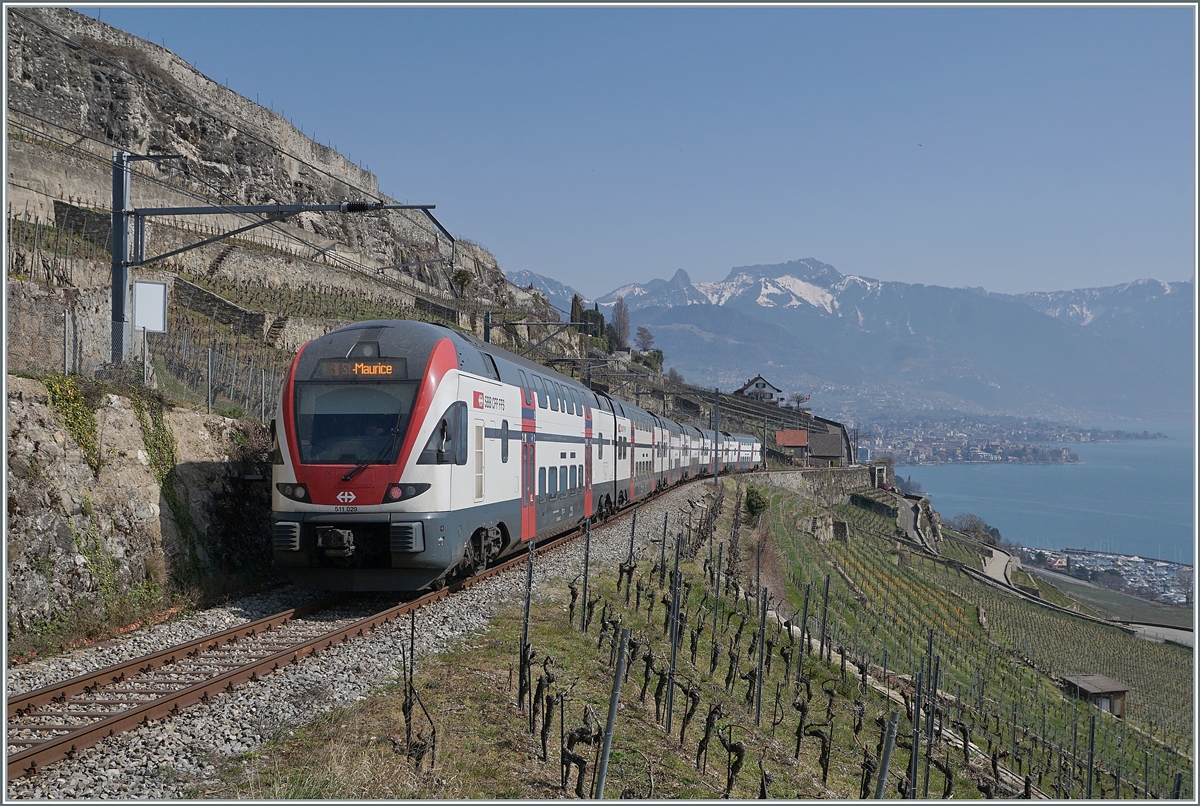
[896,423,1195,564]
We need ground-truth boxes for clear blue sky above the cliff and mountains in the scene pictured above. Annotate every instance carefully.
[77,6,1196,296]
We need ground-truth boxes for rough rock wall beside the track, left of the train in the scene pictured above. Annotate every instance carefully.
[6,375,270,633]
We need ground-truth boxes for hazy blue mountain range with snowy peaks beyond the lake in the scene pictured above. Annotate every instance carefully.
[588,259,1194,419]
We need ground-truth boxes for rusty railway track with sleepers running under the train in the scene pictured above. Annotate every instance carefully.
[7,520,595,780]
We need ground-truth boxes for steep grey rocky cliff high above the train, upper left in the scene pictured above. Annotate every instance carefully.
[6,8,553,320]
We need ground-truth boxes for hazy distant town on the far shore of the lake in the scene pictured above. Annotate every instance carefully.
[858,414,1168,465]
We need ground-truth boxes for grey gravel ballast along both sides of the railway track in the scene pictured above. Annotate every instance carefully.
[6,482,712,800]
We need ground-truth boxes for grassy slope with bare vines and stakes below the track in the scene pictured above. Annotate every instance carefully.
[206,482,1190,799]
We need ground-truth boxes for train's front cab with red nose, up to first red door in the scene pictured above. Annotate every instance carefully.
[272,323,521,590]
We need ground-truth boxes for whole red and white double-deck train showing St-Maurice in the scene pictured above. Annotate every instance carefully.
[271,320,762,590]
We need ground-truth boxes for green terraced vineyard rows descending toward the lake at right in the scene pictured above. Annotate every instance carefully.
[766,482,1193,798]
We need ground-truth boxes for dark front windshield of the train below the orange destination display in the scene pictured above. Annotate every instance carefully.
[295,380,418,464]
